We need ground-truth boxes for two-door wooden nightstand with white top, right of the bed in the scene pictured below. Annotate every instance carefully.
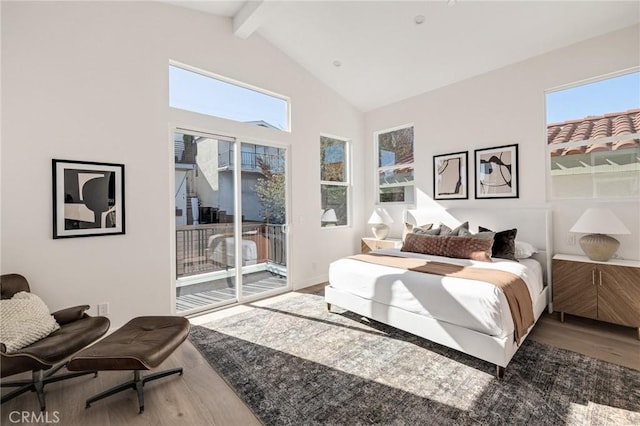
[553,254,640,339]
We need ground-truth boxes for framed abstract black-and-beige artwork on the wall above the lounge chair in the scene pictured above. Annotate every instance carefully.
[52,159,124,239]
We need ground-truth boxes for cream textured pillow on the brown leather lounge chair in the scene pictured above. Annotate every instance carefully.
[0,291,60,352]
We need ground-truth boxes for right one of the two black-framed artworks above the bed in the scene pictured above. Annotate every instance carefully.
[475,144,518,198]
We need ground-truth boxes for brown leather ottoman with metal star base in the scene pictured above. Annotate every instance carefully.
[67,316,190,413]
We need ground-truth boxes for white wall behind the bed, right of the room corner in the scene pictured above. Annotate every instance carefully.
[363,26,640,259]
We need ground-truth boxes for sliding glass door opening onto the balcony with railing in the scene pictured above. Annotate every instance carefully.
[174,131,288,313]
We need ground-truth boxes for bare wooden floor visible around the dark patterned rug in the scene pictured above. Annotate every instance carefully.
[0,293,640,426]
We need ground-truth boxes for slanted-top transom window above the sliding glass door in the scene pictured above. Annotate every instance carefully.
[169,65,289,131]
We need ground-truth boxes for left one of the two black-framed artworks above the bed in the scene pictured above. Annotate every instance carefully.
[433,151,469,200]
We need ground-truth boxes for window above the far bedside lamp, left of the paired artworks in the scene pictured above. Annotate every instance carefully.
[376,126,414,203]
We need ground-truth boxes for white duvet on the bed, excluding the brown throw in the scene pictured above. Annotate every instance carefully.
[329,249,543,337]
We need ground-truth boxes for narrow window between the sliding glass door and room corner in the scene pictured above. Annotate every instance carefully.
[320,136,349,228]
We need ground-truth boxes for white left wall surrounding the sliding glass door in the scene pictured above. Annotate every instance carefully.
[1,2,364,327]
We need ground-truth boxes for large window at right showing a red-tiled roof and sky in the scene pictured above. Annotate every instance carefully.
[546,71,640,199]
